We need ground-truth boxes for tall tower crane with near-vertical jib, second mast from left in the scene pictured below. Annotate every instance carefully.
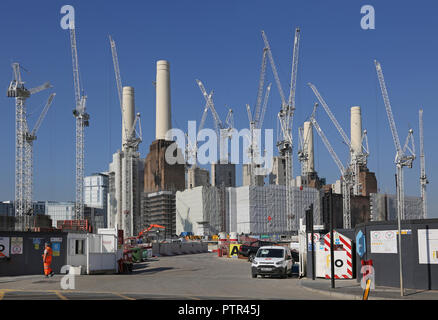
[70,21,90,220]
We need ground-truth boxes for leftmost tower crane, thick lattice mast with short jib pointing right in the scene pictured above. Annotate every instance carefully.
[7,62,51,216]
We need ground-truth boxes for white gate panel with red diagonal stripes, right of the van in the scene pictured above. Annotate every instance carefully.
[324,231,353,279]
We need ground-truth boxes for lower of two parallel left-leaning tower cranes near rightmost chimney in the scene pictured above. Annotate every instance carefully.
[310,103,353,229]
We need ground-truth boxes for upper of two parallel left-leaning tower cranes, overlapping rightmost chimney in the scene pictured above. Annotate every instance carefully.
[308,83,369,195]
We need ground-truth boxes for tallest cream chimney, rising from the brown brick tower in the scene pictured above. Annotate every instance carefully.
[155,60,172,140]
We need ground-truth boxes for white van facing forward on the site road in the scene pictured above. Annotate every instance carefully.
[251,246,294,278]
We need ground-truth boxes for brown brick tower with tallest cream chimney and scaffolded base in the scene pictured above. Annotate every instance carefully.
[137,60,186,237]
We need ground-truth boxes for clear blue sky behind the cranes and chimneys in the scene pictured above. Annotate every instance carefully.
[0,0,438,217]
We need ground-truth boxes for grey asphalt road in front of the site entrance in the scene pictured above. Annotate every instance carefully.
[0,253,327,300]
